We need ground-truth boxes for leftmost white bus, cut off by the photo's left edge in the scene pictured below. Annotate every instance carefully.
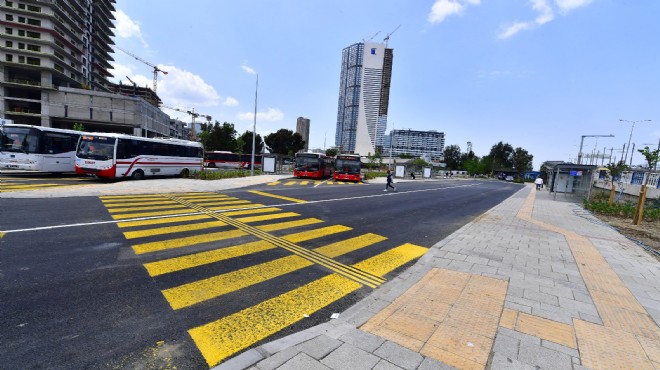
[0,124,81,173]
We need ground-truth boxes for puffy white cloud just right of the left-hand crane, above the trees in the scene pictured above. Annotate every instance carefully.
[157,65,222,111]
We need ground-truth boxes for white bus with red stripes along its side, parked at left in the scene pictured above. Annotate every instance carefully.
[75,133,204,180]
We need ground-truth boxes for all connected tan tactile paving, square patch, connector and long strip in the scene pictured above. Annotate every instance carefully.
[361,186,660,370]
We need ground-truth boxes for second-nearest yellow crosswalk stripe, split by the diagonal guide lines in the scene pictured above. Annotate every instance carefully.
[162,234,387,310]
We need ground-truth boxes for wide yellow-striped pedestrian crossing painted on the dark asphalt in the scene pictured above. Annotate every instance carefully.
[100,192,427,366]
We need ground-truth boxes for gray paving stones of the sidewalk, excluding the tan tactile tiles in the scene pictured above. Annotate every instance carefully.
[219,186,660,370]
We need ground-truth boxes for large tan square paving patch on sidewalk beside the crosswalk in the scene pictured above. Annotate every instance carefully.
[361,269,507,369]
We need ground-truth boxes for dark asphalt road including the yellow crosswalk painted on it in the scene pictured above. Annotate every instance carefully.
[0,180,519,369]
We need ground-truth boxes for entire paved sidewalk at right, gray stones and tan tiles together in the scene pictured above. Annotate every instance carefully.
[220,186,660,370]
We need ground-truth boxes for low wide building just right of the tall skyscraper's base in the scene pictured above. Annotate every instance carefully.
[383,129,445,160]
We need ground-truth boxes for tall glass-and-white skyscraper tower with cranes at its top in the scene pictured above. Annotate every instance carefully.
[335,42,394,155]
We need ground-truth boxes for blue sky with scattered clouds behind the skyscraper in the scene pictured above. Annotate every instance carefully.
[111,0,660,168]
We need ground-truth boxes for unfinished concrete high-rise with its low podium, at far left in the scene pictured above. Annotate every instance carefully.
[0,0,176,137]
